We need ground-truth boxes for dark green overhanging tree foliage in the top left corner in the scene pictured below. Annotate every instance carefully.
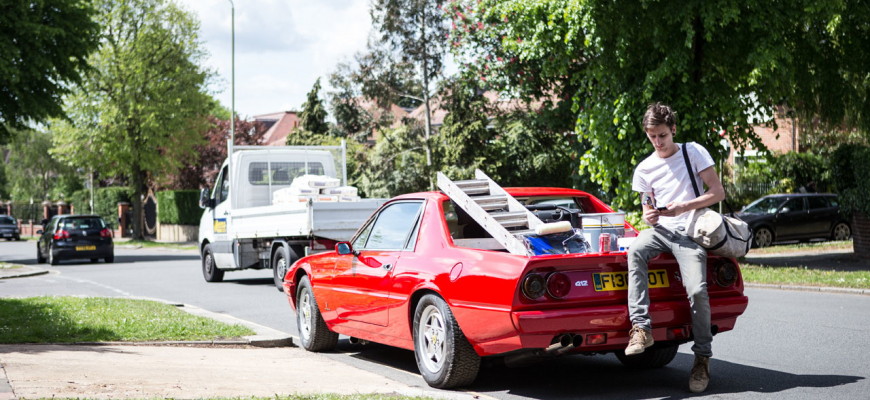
[0,0,100,144]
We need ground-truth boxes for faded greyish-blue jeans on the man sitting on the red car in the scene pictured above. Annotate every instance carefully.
[628,226,713,357]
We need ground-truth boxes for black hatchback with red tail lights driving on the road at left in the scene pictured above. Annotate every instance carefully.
[36,215,115,265]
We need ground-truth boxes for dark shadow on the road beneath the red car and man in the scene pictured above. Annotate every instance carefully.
[338,341,865,400]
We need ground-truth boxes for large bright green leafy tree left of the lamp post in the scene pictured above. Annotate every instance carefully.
[54,0,211,239]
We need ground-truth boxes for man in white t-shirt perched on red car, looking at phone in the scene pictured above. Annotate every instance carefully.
[625,103,725,393]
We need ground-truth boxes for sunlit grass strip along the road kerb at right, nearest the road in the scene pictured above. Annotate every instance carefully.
[740,264,870,289]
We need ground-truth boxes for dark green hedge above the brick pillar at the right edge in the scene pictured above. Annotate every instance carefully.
[830,144,870,216]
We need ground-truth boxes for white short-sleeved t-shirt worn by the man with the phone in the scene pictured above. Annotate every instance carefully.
[631,142,714,230]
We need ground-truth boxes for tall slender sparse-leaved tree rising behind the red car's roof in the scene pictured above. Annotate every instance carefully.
[371,0,448,173]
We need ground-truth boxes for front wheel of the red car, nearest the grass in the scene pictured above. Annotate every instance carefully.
[296,276,338,352]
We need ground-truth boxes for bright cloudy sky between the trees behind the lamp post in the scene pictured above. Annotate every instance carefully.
[177,0,371,117]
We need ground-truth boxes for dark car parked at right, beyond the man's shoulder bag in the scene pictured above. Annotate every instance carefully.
[737,193,852,247]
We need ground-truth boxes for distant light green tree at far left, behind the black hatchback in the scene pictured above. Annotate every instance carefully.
[6,129,82,201]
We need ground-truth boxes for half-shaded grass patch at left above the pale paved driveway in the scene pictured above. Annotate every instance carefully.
[0,297,254,343]
